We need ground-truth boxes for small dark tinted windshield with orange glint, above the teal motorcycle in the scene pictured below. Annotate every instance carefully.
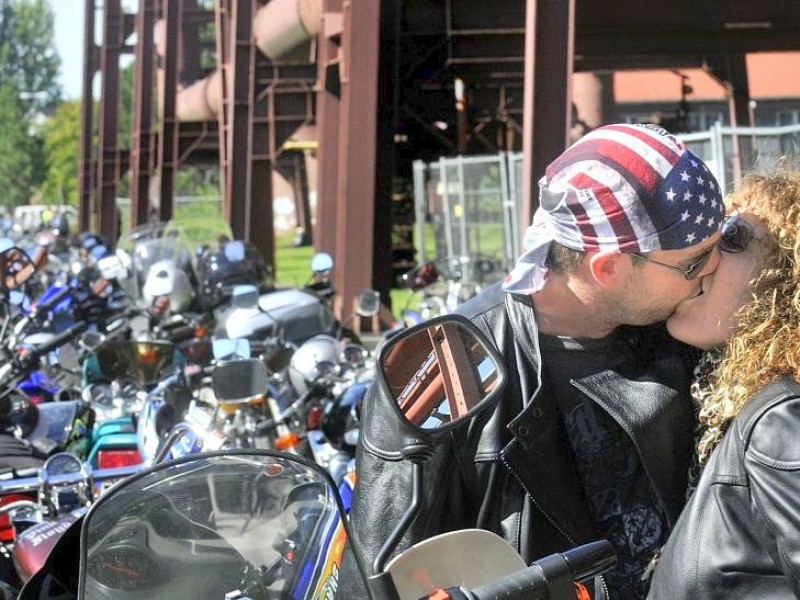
[94,341,184,386]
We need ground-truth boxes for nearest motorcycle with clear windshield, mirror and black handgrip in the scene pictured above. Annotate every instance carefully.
[20,316,615,600]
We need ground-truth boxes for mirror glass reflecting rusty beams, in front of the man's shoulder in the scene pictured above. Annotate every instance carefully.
[381,322,500,429]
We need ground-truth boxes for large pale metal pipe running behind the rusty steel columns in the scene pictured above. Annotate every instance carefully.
[164,0,322,122]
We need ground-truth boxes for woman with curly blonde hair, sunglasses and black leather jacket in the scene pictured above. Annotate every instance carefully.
[648,171,800,600]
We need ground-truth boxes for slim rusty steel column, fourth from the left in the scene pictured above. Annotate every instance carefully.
[158,0,184,222]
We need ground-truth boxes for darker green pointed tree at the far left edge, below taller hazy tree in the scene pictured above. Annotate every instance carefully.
[0,82,38,206]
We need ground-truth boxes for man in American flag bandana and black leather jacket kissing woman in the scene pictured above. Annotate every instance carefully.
[338,124,724,599]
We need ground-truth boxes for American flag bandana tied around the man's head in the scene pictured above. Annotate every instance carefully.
[503,124,725,294]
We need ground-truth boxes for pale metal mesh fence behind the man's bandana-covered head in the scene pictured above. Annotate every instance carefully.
[414,124,800,283]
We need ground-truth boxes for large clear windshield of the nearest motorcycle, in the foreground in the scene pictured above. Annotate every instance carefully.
[79,450,352,600]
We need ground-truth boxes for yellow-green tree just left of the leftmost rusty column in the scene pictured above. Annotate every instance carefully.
[39,100,81,206]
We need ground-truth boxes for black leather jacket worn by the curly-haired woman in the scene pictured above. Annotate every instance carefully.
[648,378,800,600]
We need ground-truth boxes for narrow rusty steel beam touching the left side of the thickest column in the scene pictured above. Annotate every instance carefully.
[313,0,343,255]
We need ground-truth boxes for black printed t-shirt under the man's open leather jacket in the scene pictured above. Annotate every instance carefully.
[539,334,668,600]
